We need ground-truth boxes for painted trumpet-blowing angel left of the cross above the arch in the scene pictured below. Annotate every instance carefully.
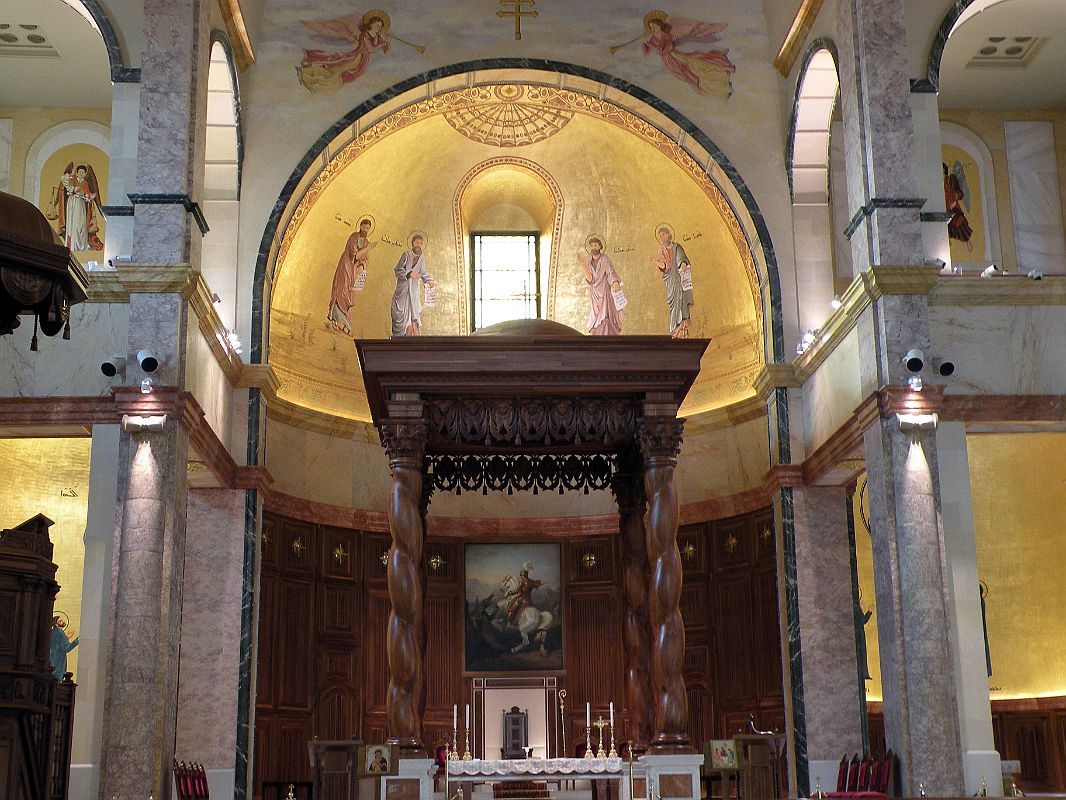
[296,9,425,92]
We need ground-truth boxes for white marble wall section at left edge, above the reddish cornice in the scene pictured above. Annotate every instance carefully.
[0,303,129,397]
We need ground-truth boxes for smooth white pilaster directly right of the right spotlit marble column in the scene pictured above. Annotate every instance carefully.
[936,422,1002,796]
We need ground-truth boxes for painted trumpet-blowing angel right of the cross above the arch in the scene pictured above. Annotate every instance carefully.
[611,11,737,97]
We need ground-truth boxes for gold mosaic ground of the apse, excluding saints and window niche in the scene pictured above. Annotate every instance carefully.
[265,77,767,420]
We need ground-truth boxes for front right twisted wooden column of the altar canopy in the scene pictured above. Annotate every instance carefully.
[641,417,690,752]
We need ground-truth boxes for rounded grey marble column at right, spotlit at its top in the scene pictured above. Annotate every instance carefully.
[863,413,964,797]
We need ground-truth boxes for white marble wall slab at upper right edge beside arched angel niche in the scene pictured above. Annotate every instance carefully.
[1003,121,1066,273]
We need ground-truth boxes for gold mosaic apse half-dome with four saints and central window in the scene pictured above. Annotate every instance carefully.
[269,83,763,419]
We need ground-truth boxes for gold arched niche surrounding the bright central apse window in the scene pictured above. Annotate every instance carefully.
[452,156,563,333]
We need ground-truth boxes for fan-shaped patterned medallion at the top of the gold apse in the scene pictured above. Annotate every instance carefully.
[445,83,574,147]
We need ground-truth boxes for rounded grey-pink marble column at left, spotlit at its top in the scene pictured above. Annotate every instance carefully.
[100,419,189,800]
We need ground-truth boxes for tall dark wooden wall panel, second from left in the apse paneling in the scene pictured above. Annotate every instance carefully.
[275,578,314,710]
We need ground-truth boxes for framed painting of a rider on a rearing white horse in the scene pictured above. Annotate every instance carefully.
[465,544,563,672]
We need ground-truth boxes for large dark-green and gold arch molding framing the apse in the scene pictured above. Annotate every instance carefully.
[249,59,786,363]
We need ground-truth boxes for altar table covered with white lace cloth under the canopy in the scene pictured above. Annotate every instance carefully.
[448,758,630,800]
